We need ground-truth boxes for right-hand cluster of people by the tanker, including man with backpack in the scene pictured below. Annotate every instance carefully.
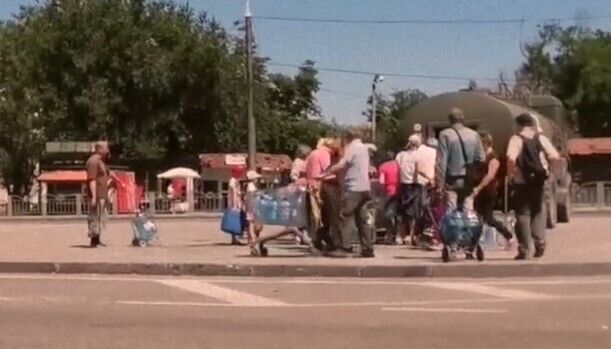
[379,108,559,260]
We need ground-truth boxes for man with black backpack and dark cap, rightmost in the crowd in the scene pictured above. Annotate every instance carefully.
[507,113,560,260]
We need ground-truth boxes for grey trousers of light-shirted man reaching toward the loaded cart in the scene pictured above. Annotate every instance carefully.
[340,191,373,253]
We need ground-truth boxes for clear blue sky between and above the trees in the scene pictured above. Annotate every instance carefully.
[0,0,611,124]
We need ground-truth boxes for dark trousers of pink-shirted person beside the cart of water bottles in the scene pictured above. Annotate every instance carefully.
[313,183,342,250]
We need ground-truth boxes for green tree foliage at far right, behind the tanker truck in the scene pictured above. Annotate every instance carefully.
[518,25,611,137]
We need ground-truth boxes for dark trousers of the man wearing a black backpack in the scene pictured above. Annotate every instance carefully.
[513,184,547,256]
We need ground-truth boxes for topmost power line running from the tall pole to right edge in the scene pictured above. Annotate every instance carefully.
[254,14,611,25]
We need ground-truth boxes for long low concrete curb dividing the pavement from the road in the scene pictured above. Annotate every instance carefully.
[0,262,611,278]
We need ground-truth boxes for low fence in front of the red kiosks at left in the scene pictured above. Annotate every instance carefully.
[0,192,227,217]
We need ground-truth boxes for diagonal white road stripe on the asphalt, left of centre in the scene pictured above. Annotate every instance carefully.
[156,279,286,307]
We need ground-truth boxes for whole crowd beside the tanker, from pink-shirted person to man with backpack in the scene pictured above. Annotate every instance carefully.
[266,108,559,259]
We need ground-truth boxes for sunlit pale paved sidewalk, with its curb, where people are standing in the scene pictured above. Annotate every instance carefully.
[0,214,611,277]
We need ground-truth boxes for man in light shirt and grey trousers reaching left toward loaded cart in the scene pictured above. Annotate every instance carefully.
[321,129,375,258]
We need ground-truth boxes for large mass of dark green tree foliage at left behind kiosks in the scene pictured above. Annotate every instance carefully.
[0,0,326,189]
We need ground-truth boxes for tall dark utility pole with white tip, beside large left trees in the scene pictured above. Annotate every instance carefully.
[244,0,257,171]
